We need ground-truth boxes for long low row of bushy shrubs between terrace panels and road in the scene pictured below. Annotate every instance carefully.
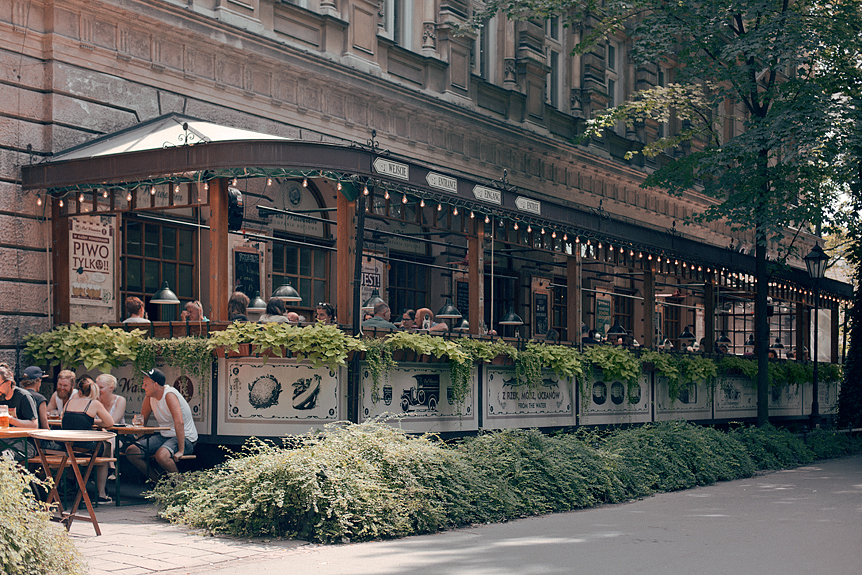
[152,421,859,543]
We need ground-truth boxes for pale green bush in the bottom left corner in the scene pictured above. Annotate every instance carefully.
[0,458,87,575]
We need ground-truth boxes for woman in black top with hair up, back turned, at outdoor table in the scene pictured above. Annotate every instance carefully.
[63,377,114,503]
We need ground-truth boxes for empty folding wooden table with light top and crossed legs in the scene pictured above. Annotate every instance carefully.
[29,429,116,535]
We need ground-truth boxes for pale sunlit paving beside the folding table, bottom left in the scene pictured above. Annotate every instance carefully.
[70,505,316,575]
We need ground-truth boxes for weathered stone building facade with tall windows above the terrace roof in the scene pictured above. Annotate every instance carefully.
[0,0,844,372]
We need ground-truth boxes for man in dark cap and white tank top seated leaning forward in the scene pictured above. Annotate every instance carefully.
[126,368,198,479]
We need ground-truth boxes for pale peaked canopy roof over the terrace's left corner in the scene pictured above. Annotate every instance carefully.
[51,113,289,162]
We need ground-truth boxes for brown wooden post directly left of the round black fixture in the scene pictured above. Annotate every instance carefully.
[209,178,233,321]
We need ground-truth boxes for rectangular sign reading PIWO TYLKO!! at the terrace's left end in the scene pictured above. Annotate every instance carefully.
[69,216,114,307]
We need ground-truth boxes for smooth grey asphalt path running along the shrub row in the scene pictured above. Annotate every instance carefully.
[201,456,862,575]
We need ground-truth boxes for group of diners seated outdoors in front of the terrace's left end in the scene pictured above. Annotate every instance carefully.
[0,364,198,503]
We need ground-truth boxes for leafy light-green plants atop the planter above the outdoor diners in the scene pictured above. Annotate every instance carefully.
[24,323,145,372]
